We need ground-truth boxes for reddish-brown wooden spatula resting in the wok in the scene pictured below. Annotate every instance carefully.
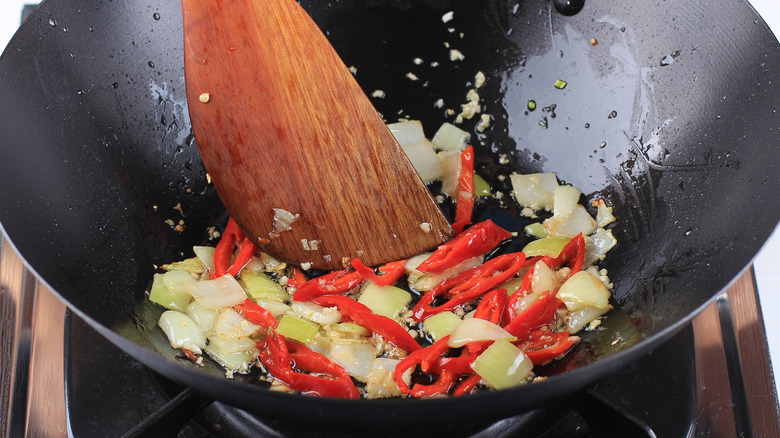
[182,0,452,269]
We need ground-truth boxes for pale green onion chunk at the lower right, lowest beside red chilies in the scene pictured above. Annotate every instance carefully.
[471,339,534,389]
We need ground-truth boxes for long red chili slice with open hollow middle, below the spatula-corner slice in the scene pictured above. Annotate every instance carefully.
[412,252,525,321]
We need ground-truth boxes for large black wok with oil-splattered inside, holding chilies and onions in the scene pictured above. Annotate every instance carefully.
[0,0,780,424]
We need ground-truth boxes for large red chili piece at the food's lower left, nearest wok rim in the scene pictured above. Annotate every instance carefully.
[258,330,360,399]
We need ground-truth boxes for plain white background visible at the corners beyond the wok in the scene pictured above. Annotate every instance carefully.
[0,0,780,388]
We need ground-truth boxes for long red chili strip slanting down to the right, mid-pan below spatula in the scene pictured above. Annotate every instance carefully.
[312,295,420,351]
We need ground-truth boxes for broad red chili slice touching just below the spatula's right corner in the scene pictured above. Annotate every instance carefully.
[417,220,512,274]
